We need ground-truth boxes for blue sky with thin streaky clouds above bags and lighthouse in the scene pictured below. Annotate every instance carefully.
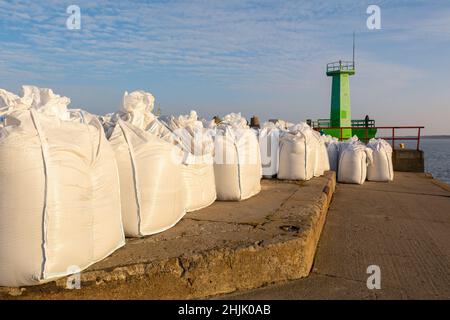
[0,0,450,134]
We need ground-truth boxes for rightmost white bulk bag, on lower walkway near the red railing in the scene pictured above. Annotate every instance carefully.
[367,139,394,182]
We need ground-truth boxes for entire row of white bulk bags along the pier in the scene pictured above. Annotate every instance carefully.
[0,86,393,286]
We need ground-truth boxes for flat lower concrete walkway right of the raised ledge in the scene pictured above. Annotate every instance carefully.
[220,172,450,299]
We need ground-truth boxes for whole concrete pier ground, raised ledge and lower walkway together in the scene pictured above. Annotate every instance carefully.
[0,172,450,299]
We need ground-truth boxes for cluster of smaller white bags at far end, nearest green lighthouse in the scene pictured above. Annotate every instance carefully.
[258,121,394,184]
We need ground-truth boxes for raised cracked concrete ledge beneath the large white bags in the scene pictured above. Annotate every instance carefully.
[0,172,335,299]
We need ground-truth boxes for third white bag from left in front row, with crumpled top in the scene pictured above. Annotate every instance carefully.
[156,111,217,212]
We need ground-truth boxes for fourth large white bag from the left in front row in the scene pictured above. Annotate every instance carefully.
[214,120,262,201]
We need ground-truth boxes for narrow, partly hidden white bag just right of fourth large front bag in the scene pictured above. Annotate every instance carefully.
[258,122,280,178]
